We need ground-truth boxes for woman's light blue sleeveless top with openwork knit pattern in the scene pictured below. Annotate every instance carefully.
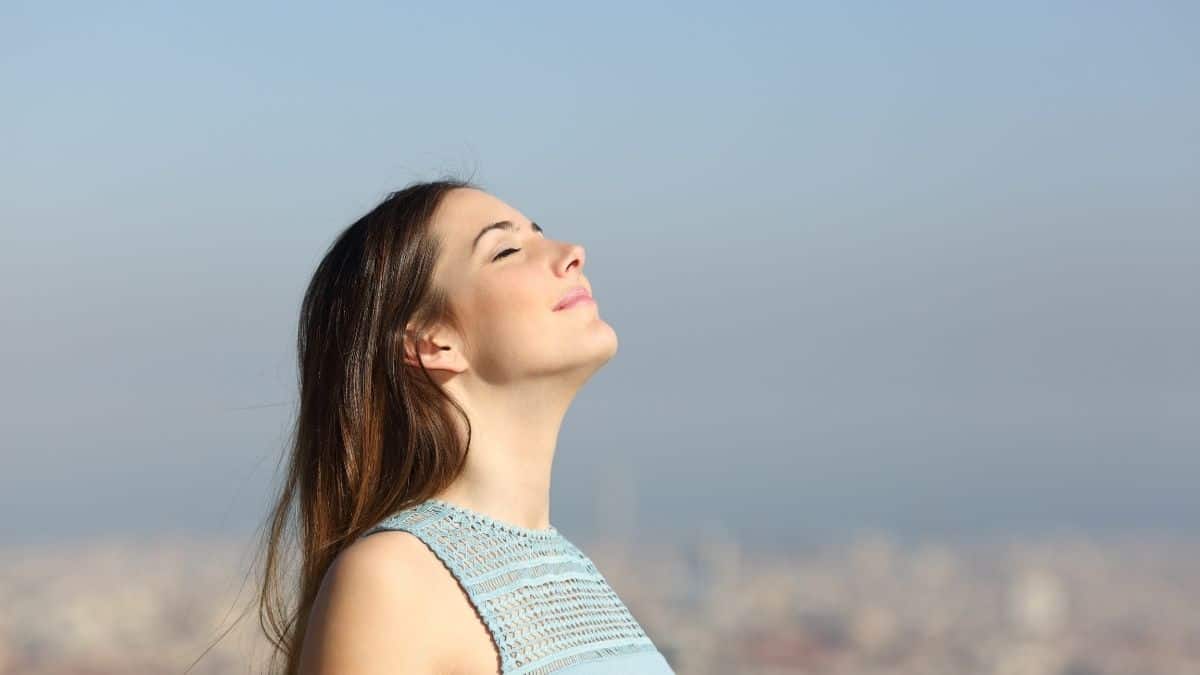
[362,498,674,675]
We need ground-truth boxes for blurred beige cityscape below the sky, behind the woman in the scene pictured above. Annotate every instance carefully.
[0,528,1200,675]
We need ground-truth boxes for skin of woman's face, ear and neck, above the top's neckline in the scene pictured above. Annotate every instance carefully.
[406,189,618,530]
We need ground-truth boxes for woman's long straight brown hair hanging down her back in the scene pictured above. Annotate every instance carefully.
[241,178,478,675]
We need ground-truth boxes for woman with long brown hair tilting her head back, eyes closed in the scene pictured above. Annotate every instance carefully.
[259,179,672,675]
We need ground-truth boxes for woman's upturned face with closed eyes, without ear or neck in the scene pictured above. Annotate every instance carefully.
[432,189,617,382]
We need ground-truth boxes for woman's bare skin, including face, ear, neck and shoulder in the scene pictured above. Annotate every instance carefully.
[300,189,617,675]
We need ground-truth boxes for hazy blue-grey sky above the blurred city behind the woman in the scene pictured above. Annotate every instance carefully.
[0,1,1200,547]
